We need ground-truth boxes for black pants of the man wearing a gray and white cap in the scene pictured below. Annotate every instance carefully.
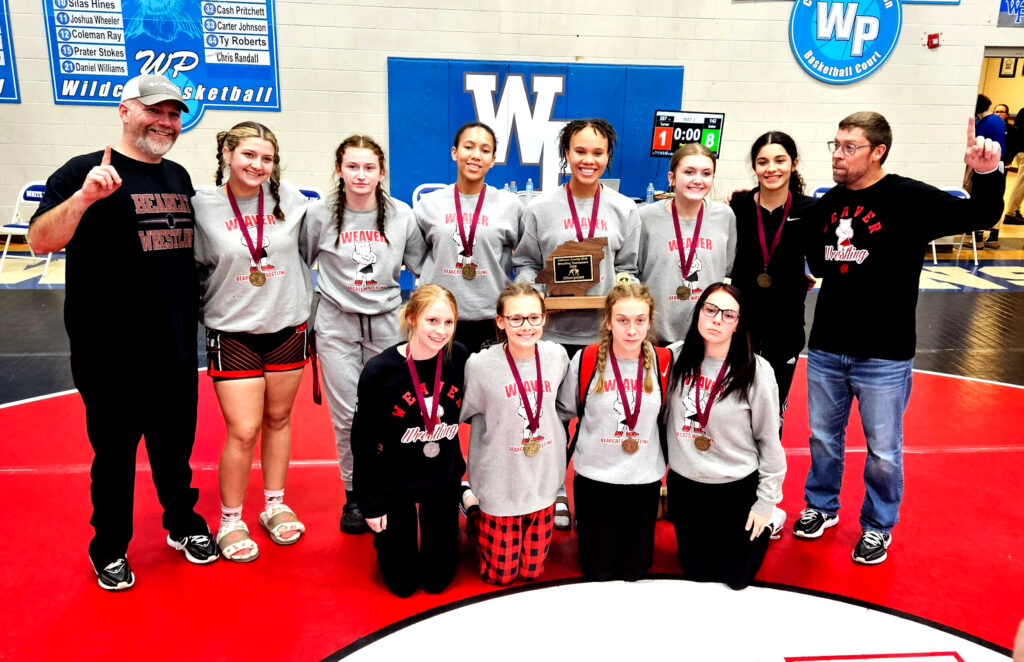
[71,356,209,569]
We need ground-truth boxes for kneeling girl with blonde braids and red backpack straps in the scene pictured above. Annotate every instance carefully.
[566,284,670,581]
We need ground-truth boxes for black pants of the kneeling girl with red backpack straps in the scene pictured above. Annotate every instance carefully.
[572,473,662,581]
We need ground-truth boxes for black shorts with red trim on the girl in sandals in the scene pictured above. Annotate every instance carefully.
[206,322,309,381]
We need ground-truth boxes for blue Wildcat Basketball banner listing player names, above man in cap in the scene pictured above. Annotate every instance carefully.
[43,0,281,130]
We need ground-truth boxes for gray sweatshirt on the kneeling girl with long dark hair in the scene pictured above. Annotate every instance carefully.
[666,352,785,515]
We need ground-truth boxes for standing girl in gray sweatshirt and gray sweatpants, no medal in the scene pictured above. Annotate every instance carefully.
[307,135,426,534]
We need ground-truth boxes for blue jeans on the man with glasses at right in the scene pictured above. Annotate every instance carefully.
[804,349,913,534]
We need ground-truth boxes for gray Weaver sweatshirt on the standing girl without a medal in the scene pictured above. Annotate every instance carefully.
[307,194,427,315]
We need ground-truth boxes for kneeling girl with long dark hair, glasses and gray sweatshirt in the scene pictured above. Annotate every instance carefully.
[666,283,785,589]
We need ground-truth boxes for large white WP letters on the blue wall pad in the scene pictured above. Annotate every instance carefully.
[463,73,565,191]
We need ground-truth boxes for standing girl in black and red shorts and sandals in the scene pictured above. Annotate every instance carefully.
[192,122,312,562]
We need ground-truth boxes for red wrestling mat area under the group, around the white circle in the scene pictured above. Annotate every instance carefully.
[0,363,1024,661]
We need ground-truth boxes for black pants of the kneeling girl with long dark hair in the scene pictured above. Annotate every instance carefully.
[669,470,771,590]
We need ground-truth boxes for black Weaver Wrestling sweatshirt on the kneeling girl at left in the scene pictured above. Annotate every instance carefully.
[352,342,469,518]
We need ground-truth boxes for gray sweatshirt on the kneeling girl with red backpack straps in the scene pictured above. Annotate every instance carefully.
[565,351,665,485]
